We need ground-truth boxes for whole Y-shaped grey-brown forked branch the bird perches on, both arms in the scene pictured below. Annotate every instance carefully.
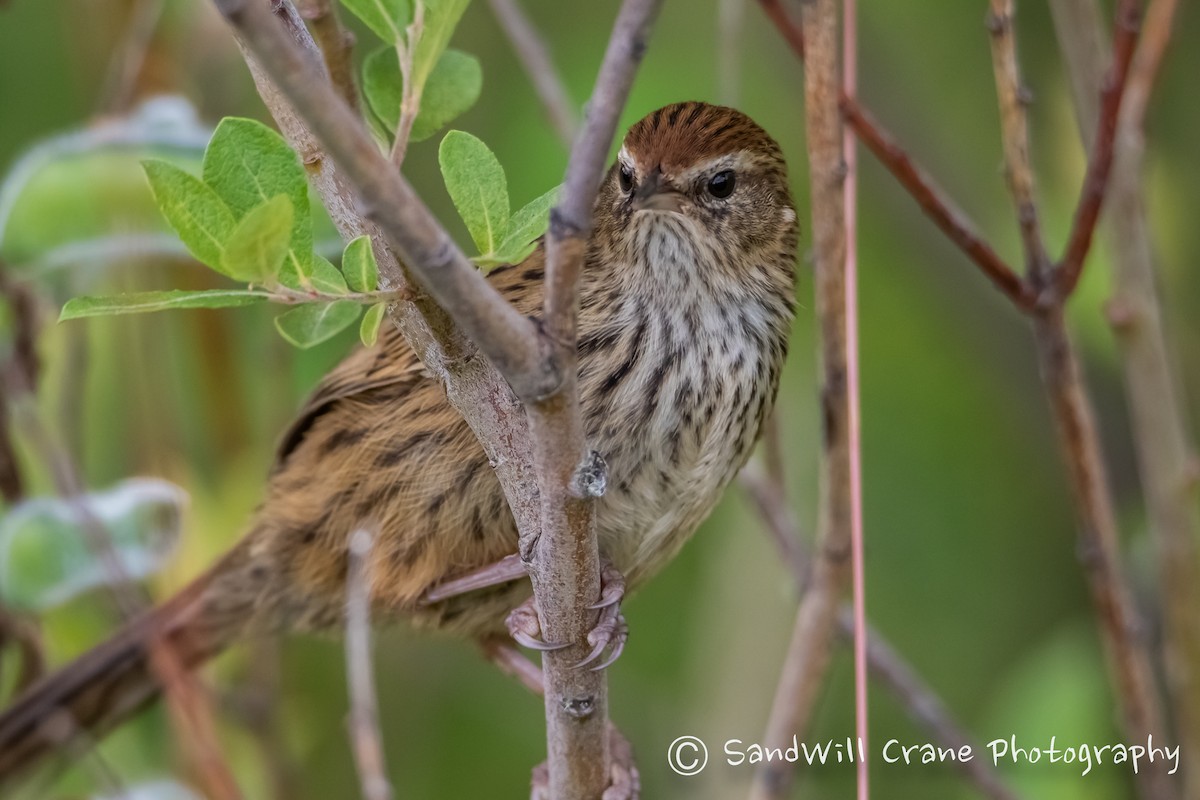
[215,0,660,798]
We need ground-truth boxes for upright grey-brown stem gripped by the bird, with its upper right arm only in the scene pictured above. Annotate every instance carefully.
[530,0,662,799]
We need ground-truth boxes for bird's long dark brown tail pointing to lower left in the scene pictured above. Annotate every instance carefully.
[0,548,252,787]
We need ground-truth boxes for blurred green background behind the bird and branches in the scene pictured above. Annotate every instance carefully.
[0,0,1200,800]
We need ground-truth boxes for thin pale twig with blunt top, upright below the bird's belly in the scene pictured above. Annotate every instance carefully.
[346,529,391,800]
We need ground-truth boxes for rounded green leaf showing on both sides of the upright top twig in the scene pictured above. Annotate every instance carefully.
[362,48,484,142]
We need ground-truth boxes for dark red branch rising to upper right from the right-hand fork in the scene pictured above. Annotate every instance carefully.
[1055,0,1139,301]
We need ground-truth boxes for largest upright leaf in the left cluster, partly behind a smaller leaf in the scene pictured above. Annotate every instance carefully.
[204,116,312,289]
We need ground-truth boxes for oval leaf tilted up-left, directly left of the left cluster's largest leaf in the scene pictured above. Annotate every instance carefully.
[142,160,235,275]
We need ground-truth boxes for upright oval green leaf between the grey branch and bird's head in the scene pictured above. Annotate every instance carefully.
[438,131,509,253]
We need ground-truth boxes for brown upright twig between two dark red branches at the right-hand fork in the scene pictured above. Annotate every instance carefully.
[988,0,1050,282]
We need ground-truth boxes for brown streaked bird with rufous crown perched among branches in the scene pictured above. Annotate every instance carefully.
[0,103,797,783]
